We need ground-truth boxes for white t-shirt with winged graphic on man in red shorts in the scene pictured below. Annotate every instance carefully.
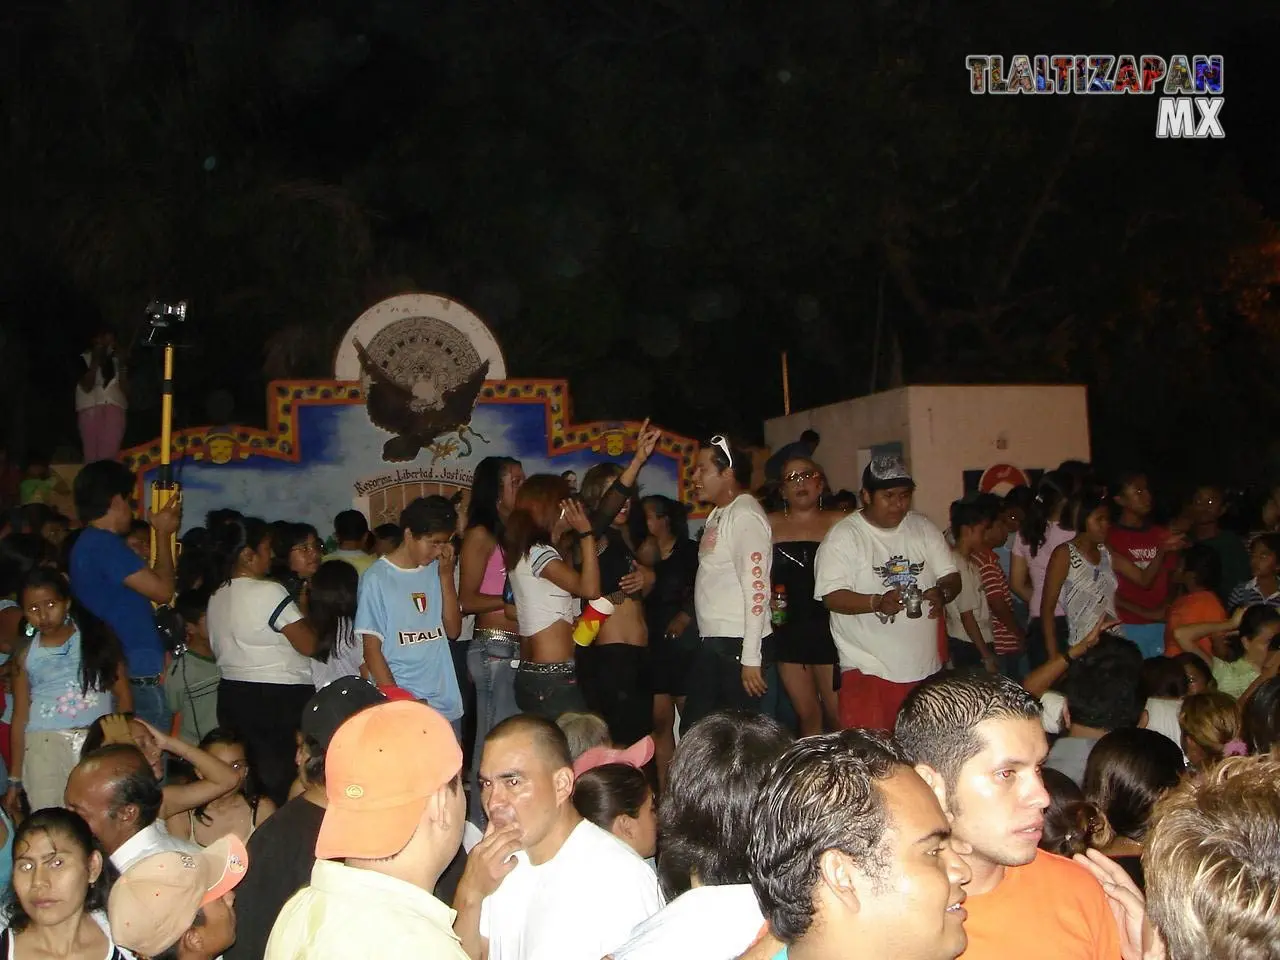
[814,512,956,684]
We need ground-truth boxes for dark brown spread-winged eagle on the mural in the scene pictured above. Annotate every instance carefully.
[352,335,489,463]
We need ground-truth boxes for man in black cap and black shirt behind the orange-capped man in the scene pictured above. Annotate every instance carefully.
[223,677,387,960]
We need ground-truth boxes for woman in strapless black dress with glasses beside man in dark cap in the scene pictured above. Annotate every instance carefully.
[769,457,844,737]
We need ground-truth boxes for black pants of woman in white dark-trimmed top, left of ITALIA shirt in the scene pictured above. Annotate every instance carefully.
[218,678,316,806]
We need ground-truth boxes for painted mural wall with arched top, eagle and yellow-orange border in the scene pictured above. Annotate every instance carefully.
[123,294,696,536]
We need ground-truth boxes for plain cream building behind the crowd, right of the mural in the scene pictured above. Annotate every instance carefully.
[764,385,1089,526]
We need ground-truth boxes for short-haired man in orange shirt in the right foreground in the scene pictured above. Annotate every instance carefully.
[895,672,1120,960]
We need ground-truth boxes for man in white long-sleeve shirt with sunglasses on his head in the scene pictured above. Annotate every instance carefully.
[681,436,773,730]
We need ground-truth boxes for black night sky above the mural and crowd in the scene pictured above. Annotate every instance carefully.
[0,0,1280,496]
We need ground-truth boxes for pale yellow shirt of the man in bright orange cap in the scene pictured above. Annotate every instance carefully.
[264,860,467,960]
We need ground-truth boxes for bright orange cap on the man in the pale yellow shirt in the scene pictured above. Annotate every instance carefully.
[316,700,462,860]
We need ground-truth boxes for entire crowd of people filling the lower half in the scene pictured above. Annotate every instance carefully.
[0,422,1280,960]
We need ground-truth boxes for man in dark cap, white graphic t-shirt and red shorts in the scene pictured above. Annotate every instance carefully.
[814,456,960,730]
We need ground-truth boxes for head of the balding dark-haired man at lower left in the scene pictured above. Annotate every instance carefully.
[64,744,164,854]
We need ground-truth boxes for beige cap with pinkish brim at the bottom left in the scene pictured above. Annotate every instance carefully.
[106,833,248,956]
